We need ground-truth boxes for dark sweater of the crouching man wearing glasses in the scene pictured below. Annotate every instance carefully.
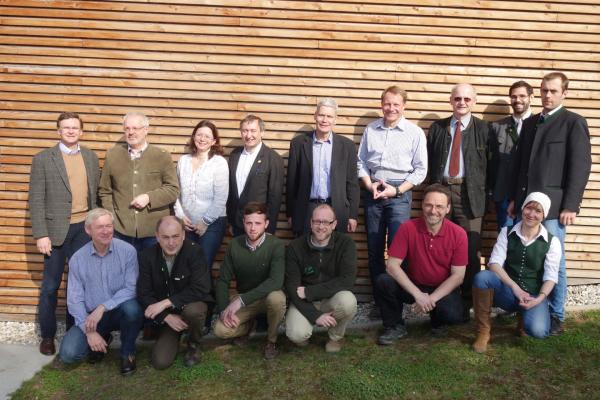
[285,232,356,324]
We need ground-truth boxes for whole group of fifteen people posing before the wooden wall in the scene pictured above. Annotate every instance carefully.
[29,72,591,375]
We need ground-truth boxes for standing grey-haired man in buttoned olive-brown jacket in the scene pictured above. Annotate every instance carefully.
[98,112,179,252]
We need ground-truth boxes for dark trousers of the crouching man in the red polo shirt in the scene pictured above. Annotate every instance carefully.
[375,273,463,328]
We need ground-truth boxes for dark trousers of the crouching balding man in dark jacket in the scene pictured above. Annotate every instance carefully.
[152,301,207,369]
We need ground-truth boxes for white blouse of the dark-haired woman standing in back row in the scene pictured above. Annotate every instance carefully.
[175,154,229,225]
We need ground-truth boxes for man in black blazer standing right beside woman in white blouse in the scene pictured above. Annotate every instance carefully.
[227,115,283,236]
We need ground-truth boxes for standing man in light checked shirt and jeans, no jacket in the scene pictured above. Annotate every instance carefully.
[358,86,427,319]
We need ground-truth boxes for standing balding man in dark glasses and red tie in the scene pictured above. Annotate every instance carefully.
[427,83,490,321]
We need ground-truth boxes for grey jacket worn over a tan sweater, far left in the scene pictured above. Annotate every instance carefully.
[29,144,100,246]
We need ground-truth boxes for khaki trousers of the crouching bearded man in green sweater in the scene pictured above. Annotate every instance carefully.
[214,290,286,343]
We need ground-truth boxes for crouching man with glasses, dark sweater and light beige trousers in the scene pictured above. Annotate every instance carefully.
[285,204,356,353]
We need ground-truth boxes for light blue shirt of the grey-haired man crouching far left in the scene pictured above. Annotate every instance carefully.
[67,238,139,333]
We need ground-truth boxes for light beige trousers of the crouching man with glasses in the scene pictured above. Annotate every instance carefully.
[285,290,356,343]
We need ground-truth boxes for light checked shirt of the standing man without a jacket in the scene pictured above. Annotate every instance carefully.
[358,117,427,186]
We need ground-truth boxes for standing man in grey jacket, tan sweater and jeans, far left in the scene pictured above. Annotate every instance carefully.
[29,113,100,355]
